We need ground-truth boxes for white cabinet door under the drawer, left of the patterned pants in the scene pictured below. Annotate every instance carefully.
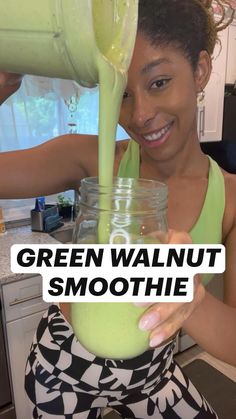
[7,311,44,419]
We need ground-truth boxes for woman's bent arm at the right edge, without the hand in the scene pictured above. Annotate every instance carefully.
[183,215,236,366]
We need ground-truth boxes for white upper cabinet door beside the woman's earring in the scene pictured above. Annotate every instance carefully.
[198,29,228,141]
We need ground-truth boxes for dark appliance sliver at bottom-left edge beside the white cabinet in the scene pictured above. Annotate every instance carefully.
[0,300,16,419]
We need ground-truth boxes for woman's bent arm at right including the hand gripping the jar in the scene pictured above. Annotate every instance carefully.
[137,223,236,366]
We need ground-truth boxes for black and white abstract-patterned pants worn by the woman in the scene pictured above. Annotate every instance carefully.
[25,305,217,419]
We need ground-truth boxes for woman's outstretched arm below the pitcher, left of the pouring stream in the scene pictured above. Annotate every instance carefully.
[0,134,98,199]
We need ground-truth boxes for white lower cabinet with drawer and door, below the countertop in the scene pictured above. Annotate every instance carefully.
[3,275,48,419]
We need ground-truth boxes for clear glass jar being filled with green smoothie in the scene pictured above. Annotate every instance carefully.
[71,177,167,359]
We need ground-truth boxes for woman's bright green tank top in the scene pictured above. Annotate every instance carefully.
[117,140,225,285]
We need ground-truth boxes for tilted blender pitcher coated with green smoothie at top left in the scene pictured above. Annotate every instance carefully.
[0,0,138,87]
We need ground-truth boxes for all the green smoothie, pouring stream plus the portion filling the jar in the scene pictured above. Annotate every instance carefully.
[71,0,152,358]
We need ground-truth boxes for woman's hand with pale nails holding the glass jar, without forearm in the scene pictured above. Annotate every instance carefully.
[137,230,205,347]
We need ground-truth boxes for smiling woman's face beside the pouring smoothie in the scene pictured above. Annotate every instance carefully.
[120,34,201,160]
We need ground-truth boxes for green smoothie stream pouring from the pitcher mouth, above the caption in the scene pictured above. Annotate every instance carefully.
[93,0,135,244]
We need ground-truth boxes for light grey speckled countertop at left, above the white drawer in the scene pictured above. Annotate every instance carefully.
[0,224,72,286]
